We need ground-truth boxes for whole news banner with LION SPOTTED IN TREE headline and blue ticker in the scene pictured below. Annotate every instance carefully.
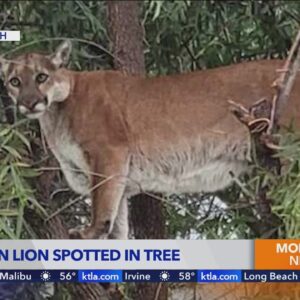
[0,240,300,283]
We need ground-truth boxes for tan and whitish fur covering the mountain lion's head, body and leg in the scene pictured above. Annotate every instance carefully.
[2,42,300,238]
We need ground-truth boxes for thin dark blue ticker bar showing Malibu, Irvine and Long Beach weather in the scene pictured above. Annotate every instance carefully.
[0,270,300,284]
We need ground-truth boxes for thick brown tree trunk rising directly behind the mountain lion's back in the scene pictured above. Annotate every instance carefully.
[107,1,168,300]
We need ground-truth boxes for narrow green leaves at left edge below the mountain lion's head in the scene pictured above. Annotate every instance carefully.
[0,119,41,239]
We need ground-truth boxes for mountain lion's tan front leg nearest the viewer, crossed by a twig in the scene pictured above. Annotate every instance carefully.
[69,150,129,239]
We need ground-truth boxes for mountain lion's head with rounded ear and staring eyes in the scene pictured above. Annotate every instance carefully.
[0,41,72,118]
